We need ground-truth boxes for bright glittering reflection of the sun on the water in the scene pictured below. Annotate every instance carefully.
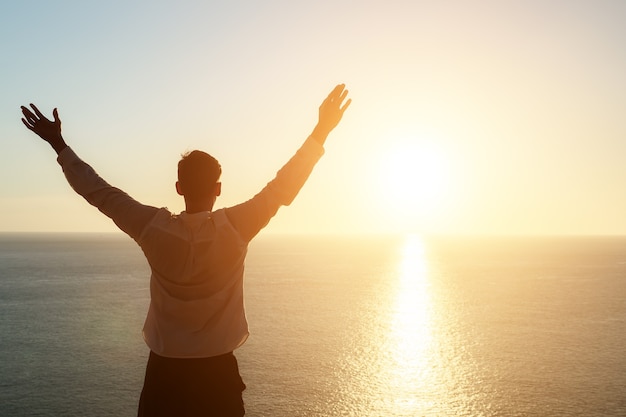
[337,232,447,417]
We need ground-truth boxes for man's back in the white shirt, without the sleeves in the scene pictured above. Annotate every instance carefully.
[138,210,248,358]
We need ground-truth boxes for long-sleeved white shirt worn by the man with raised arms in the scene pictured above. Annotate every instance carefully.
[58,137,324,358]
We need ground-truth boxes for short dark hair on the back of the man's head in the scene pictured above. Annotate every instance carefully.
[178,150,222,198]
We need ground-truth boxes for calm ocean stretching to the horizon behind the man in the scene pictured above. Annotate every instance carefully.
[0,233,626,417]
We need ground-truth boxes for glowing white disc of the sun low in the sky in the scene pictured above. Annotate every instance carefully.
[378,139,450,221]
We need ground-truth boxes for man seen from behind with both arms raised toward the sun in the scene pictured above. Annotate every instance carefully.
[21,84,351,416]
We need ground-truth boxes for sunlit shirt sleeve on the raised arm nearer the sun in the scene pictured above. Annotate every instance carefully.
[225,137,324,241]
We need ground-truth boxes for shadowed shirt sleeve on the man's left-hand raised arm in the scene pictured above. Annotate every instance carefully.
[57,147,158,240]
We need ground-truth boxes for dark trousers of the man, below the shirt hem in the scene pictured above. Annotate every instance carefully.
[137,352,246,417]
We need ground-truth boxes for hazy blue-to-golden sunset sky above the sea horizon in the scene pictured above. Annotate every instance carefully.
[0,0,626,235]
